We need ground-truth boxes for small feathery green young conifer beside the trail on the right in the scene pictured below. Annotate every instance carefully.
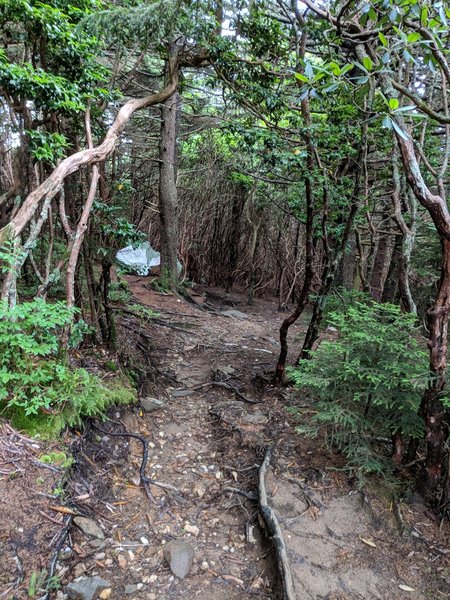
[290,298,428,474]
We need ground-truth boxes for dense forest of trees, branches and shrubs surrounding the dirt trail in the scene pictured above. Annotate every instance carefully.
[0,0,450,511]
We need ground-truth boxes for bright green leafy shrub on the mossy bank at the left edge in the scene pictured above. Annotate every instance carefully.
[0,299,135,437]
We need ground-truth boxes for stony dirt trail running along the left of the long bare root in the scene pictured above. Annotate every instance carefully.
[59,280,290,600]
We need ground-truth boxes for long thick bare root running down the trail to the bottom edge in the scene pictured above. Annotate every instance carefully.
[258,446,297,600]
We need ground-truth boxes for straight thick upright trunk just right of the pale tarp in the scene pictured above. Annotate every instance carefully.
[159,86,178,289]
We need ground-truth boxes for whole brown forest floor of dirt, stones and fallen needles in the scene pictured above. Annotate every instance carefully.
[0,276,450,600]
